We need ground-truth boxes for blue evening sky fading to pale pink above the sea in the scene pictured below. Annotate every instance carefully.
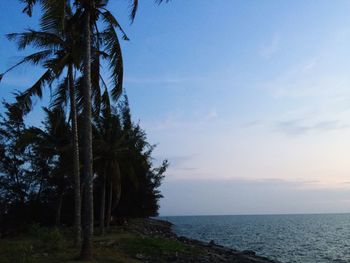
[0,0,350,216]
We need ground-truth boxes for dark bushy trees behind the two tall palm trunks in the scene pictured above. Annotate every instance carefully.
[0,96,168,234]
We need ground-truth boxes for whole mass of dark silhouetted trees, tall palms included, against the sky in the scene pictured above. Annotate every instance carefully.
[0,0,168,260]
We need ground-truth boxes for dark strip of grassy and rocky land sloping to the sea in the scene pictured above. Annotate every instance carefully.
[0,218,278,263]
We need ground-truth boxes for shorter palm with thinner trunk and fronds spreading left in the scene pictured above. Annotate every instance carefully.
[2,6,81,245]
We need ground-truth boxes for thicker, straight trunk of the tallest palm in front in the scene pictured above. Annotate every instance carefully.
[81,7,94,260]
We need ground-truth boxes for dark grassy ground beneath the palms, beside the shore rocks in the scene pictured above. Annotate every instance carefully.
[0,226,201,263]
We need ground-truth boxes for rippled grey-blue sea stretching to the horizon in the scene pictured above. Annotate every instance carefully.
[162,214,350,263]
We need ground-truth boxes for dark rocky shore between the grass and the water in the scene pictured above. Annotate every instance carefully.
[124,219,277,263]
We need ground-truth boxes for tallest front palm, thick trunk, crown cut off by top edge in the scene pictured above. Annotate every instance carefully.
[16,0,168,260]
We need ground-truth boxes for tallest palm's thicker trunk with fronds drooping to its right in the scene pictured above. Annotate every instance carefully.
[76,0,167,260]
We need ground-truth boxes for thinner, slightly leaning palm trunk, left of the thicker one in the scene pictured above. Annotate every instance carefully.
[68,64,81,247]
